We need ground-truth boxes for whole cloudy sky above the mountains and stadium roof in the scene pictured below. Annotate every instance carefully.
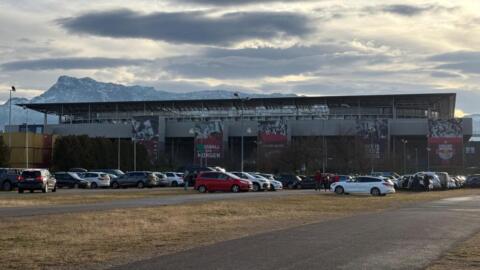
[0,0,480,113]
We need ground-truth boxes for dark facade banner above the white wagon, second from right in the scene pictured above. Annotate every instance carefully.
[356,119,389,159]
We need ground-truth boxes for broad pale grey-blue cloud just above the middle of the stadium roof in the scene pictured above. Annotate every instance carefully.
[165,46,389,79]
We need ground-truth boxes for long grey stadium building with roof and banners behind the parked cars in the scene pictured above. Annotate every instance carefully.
[7,93,472,173]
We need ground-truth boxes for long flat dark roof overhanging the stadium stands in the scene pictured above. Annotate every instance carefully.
[17,93,456,117]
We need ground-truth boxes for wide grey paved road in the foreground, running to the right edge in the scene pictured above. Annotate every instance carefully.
[114,196,480,270]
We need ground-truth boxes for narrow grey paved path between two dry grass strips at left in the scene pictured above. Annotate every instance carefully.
[0,190,315,217]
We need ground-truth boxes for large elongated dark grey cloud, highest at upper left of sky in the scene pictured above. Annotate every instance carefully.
[58,10,313,45]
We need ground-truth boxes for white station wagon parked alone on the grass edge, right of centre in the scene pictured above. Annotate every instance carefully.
[330,176,395,196]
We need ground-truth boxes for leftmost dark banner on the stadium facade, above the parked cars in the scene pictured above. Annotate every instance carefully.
[132,116,160,164]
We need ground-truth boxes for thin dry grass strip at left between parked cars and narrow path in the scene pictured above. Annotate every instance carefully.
[0,189,197,207]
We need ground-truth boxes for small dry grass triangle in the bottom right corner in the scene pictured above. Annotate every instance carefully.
[427,230,480,270]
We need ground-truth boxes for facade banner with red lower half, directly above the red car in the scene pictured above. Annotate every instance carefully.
[194,121,223,159]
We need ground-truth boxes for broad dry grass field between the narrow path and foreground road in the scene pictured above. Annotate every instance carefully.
[0,190,480,269]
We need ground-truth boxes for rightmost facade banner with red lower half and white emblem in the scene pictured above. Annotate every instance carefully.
[428,119,463,167]
